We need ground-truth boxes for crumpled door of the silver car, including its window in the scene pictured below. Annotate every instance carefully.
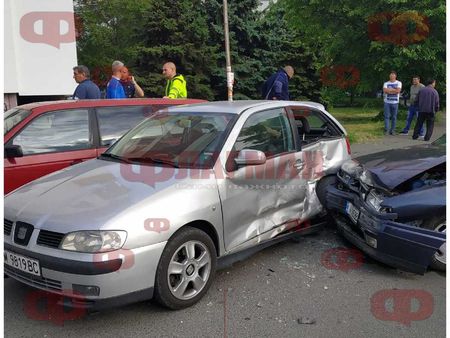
[216,108,306,251]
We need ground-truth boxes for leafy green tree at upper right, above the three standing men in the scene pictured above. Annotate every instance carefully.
[285,0,445,105]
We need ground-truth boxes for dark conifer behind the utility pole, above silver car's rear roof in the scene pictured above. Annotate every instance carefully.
[205,0,319,100]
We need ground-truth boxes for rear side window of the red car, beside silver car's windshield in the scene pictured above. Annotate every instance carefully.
[96,106,154,146]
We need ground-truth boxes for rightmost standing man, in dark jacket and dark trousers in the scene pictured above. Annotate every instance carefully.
[413,79,439,141]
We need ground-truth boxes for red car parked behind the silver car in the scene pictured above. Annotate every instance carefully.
[4,99,205,194]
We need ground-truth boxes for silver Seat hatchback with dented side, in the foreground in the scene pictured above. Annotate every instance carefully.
[4,101,350,309]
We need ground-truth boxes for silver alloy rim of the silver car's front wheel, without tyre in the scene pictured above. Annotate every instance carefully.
[167,241,211,300]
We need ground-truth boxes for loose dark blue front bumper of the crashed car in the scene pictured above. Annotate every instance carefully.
[327,185,446,274]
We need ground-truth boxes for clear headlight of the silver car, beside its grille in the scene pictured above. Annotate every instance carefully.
[61,230,127,253]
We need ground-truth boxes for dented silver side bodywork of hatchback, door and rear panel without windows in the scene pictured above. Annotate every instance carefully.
[215,104,349,253]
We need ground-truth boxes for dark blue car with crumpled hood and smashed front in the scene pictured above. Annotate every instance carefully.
[322,135,446,274]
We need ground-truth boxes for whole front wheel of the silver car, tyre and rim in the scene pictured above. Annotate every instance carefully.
[155,226,217,310]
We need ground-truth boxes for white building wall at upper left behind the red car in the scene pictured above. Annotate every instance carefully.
[4,0,77,109]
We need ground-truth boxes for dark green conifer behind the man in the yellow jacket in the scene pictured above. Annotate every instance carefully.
[136,0,218,100]
